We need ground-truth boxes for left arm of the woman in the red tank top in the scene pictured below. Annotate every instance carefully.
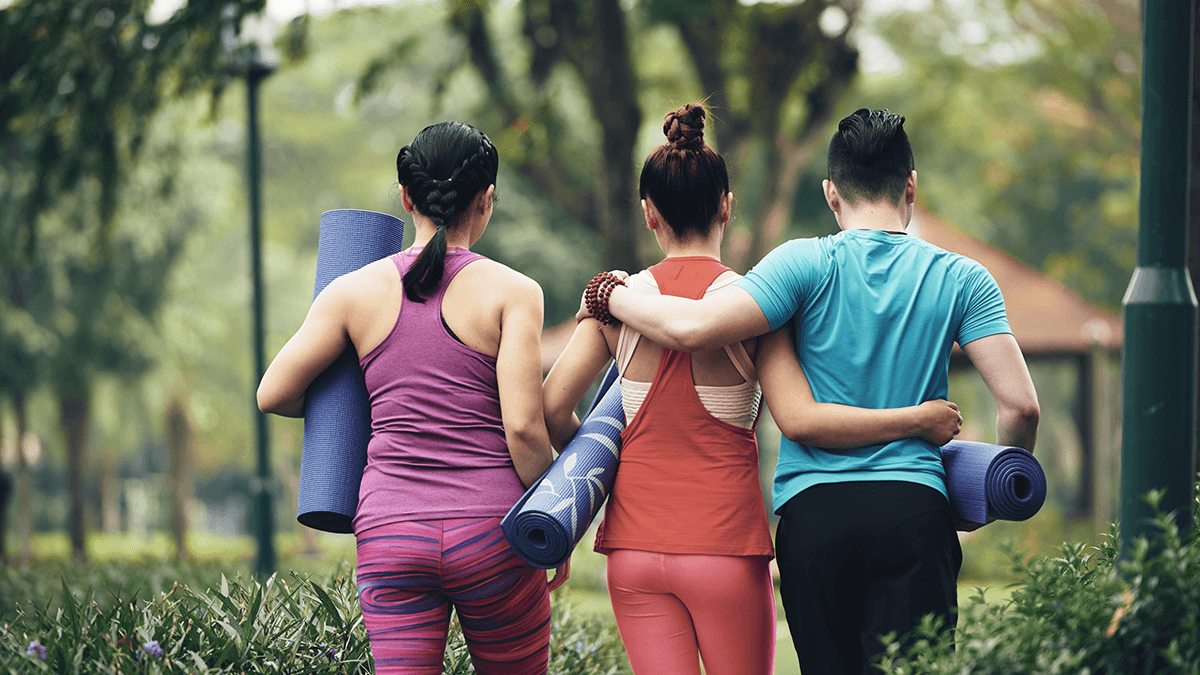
[541,318,611,452]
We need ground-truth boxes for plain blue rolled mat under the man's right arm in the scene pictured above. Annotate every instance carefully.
[942,441,1046,532]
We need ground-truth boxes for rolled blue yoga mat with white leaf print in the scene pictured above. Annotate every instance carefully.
[500,369,625,569]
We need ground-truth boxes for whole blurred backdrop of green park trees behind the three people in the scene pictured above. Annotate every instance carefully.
[0,0,1140,566]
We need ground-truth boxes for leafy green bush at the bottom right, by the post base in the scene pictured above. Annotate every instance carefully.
[881,494,1200,675]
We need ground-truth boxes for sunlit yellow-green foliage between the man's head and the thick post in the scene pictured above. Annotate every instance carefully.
[863,0,1137,309]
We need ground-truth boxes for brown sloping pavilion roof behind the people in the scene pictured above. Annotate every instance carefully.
[541,207,1122,372]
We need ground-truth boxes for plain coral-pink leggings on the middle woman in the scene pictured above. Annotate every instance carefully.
[608,549,775,675]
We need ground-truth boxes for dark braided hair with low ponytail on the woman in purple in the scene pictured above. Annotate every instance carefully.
[396,121,500,303]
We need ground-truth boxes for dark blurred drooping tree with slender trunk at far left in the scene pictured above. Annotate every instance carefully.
[0,0,264,560]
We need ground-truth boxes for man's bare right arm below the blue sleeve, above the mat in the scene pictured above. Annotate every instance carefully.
[962,333,1042,453]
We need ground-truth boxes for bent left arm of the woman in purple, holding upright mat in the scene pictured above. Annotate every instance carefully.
[258,276,350,417]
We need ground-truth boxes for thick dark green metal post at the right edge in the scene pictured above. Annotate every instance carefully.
[1121,0,1196,555]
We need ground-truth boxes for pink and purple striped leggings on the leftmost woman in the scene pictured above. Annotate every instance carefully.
[358,518,550,675]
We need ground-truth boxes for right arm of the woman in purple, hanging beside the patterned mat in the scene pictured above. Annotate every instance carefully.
[496,275,553,488]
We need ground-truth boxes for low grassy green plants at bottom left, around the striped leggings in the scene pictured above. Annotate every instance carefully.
[0,563,628,675]
